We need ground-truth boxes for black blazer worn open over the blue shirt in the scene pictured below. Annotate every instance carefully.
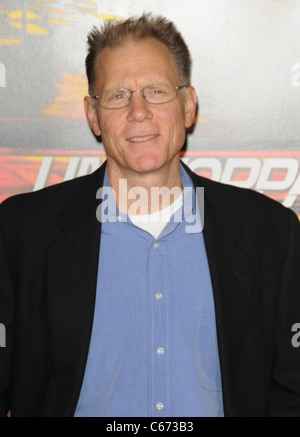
[0,164,300,417]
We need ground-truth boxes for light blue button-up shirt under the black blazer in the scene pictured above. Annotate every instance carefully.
[75,164,223,417]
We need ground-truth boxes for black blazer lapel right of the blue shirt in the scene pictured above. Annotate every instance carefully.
[189,164,254,416]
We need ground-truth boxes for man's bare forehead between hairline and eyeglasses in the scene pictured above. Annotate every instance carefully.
[96,38,180,89]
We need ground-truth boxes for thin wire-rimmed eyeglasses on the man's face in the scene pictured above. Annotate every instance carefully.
[92,83,188,109]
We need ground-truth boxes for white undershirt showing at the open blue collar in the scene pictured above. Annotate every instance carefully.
[129,194,183,239]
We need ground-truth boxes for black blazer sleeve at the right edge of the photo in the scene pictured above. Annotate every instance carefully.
[267,211,300,417]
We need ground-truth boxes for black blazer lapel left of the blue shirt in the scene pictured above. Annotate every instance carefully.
[48,164,105,416]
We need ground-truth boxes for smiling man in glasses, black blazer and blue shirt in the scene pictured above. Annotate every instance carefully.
[0,15,300,417]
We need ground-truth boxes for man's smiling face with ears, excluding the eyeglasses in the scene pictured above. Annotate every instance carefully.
[85,39,196,178]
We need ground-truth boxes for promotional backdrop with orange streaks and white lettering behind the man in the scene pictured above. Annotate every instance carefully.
[0,0,300,217]
